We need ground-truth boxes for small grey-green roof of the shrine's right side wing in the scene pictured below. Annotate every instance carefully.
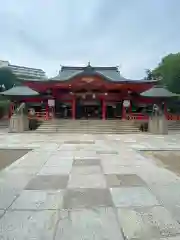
[141,86,178,98]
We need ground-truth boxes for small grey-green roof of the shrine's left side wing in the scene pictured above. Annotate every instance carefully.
[0,86,39,96]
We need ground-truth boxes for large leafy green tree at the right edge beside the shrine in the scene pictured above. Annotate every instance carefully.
[152,53,180,93]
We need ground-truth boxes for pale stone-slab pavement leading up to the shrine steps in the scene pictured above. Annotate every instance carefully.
[0,133,180,240]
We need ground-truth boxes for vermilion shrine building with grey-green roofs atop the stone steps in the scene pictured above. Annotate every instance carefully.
[3,64,176,119]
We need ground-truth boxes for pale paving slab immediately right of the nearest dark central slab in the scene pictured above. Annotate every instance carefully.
[110,187,159,207]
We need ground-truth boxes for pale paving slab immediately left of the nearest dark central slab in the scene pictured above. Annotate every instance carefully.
[10,190,64,210]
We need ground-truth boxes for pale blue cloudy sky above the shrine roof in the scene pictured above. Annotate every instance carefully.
[0,0,180,79]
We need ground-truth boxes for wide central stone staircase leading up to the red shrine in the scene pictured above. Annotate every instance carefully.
[36,119,140,134]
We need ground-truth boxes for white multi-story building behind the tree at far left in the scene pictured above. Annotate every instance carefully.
[0,60,47,80]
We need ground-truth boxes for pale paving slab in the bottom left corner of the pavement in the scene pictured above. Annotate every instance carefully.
[0,210,59,240]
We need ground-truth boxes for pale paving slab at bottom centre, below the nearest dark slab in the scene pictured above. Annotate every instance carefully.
[55,208,123,240]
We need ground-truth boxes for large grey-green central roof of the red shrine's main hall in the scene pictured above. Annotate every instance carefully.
[49,65,156,83]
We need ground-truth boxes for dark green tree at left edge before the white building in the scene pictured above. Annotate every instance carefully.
[0,67,18,92]
